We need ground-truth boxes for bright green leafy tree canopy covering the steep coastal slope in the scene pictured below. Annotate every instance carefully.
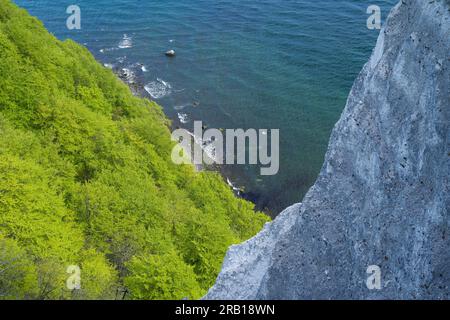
[0,0,268,299]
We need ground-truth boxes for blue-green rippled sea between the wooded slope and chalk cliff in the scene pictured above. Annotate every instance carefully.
[15,0,397,212]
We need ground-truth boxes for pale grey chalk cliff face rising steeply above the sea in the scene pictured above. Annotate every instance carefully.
[205,0,450,299]
